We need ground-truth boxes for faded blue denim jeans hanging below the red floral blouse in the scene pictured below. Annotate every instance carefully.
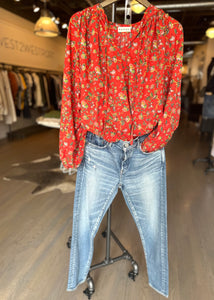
[67,131,168,298]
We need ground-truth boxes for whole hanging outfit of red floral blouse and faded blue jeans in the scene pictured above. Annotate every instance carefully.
[59,3,183,297]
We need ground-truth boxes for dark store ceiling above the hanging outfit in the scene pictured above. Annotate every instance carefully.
[0,0,214,51]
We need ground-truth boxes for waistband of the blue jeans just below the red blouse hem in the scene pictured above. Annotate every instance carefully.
[86,131,149,147]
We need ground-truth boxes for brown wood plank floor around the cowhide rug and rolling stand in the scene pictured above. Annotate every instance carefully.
[0,111,214,300]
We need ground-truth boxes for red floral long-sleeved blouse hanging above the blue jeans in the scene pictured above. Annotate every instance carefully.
[59,3,183,169]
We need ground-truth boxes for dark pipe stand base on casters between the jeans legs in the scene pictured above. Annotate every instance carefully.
[67,206,139,299]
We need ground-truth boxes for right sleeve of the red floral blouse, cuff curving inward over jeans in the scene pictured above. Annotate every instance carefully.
[141,23,183,152]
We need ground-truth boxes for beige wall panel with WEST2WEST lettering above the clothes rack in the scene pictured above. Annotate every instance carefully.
[0,8,65,71]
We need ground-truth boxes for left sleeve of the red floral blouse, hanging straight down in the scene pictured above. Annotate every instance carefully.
[59,14,83,169]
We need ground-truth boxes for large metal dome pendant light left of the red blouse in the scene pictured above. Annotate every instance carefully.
[34,0,60,37]
